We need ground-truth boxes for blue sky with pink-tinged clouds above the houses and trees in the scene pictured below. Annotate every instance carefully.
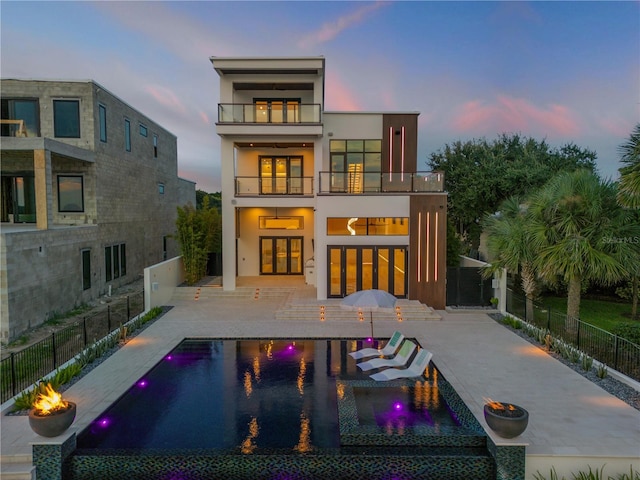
[0,1,640,192]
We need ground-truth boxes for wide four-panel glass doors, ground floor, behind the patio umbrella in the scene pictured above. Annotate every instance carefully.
[327,245,407,298]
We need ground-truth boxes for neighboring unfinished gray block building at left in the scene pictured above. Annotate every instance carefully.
[0,79,196,341]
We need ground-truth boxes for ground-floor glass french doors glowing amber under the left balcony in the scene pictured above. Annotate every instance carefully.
[260,237,303,275]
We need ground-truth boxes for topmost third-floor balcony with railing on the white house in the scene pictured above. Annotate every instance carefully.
[216,101,322,136]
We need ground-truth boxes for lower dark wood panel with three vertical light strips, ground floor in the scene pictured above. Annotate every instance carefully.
[408,193,447,310]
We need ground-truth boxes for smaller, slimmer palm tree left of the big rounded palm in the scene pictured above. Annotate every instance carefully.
[483,196,538,319]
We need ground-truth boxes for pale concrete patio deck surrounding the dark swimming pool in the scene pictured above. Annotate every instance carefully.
[1,277,640,479]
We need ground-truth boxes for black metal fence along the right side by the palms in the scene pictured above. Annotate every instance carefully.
[507,290,640,381]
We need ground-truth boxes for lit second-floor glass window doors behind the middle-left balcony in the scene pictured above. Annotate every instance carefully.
[260,156,303,195]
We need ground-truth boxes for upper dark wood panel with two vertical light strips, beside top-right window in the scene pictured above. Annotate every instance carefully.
[382,113,418,173]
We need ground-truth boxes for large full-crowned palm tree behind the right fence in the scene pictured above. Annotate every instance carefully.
[528,170,638,319]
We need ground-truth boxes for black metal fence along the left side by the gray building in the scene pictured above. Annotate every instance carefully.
[0,292,144,403]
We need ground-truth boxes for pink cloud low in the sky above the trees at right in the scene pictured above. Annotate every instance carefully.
[452,95,580,137]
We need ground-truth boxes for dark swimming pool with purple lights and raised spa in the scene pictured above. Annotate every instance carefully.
[65,339,495,480]
